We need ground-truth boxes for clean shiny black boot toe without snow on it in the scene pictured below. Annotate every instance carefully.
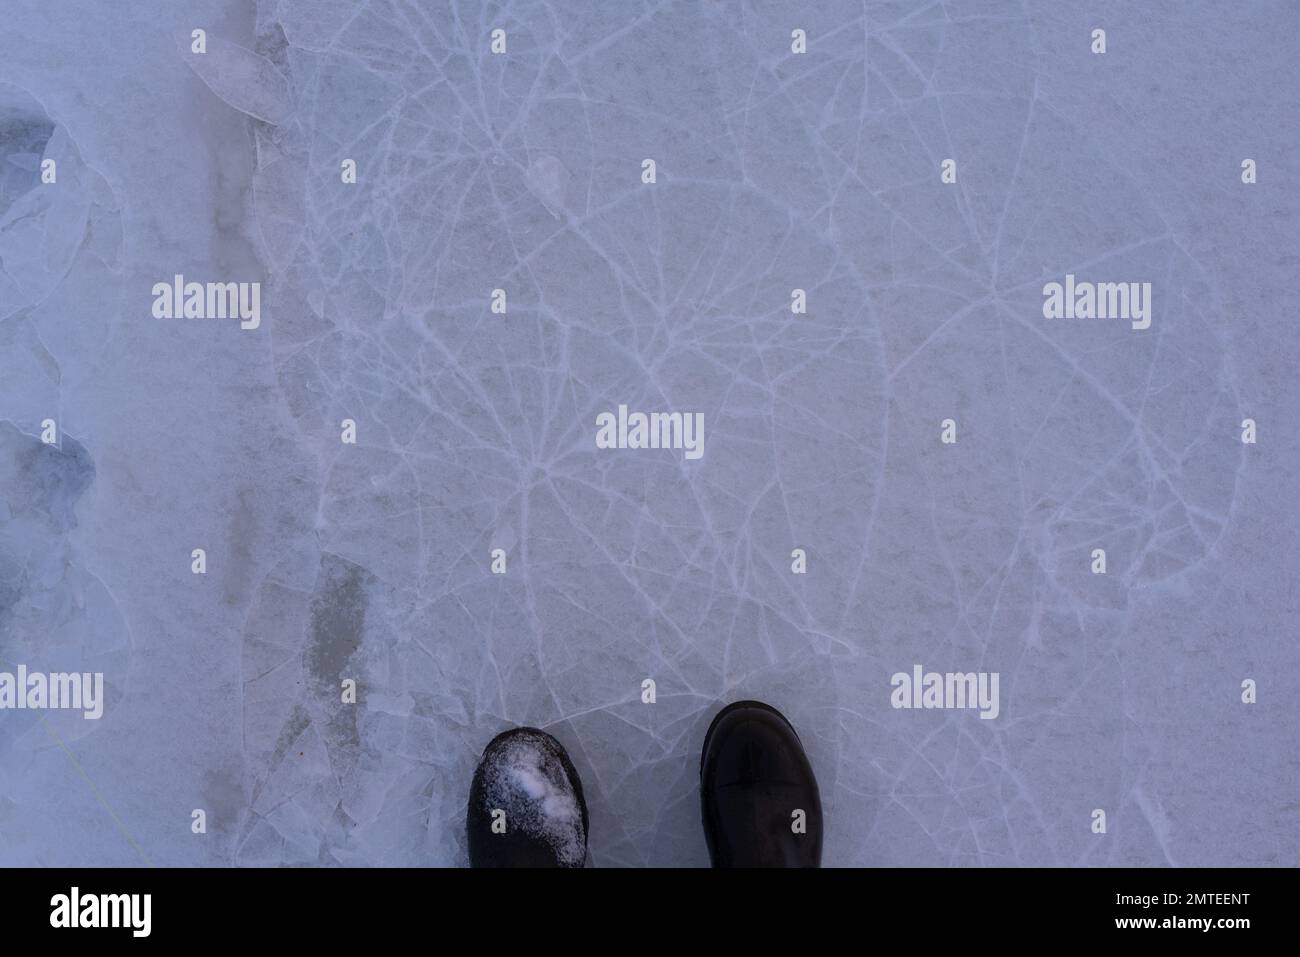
[699,701,822,867]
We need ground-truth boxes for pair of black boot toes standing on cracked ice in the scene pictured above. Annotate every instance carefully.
[465,701,822,867]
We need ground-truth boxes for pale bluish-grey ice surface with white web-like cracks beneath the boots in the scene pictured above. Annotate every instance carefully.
[0,0,1300,866]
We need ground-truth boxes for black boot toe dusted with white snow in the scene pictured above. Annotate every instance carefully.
[465,728,586,867]
